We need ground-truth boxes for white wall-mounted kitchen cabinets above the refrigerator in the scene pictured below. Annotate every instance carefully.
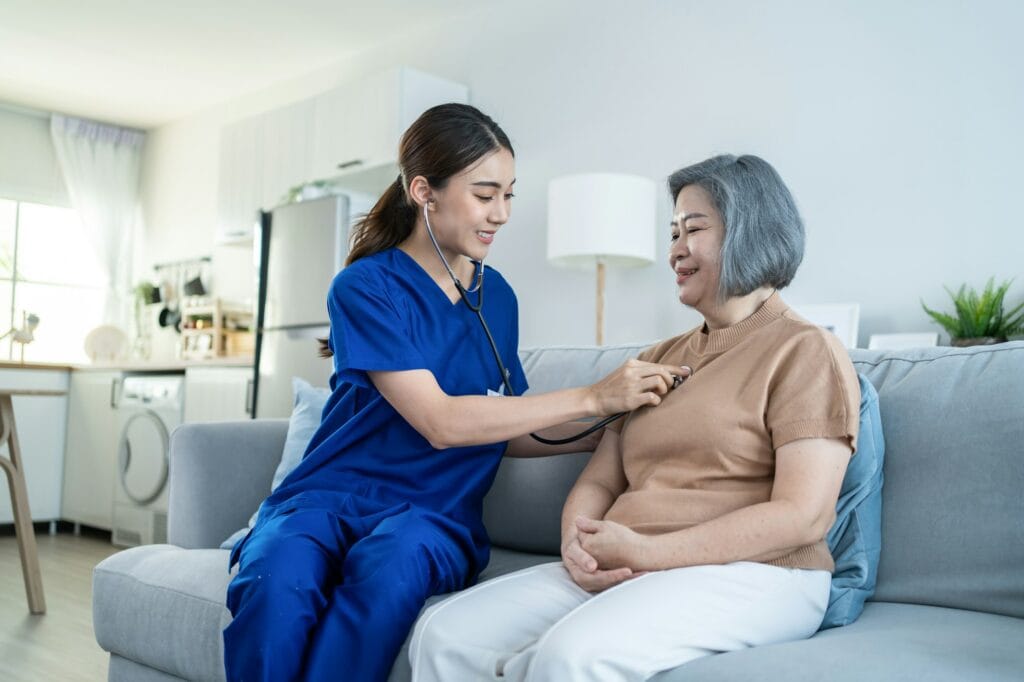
[217,68,469,244]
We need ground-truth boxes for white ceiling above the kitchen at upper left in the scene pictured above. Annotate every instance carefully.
[0,0,481,128]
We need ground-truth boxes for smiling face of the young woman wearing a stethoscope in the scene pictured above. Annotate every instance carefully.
[429,148,515,260]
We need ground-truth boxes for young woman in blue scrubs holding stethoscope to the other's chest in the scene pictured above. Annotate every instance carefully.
[224,104,686,682]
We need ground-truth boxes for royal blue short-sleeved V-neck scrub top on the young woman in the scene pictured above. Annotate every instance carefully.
[260,248,527,568]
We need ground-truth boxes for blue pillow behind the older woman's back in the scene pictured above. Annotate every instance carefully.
[821,375,886,630]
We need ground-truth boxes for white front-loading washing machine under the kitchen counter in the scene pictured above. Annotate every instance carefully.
[111,374,184,547]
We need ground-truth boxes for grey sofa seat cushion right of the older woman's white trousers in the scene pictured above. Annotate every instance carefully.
[651,602,1024,682]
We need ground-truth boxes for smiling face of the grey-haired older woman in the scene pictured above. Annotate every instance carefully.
[669,184,725,313]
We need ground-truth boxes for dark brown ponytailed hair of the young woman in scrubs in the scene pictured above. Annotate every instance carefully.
[319,103,515,357]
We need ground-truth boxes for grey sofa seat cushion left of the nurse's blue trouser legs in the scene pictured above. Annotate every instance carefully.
[92,545,231,682]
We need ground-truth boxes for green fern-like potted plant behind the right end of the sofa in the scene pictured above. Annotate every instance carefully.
[921,278,1024,346]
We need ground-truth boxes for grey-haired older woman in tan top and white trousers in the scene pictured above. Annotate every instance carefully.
[411,156,860,681]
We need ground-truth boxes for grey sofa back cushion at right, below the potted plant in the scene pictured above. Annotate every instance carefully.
[850,341,1024,617]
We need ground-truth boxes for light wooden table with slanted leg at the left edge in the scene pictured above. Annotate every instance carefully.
[0,388,66,613]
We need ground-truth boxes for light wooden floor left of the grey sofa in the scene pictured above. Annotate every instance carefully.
[0,531,119,682]
